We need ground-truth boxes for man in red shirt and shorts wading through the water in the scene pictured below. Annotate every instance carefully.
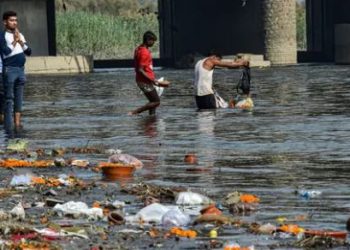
[129,31,169,115]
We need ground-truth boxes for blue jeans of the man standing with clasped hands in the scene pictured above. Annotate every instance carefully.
[3,67,26,128]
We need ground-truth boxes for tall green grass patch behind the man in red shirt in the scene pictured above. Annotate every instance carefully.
[56,11,159,59]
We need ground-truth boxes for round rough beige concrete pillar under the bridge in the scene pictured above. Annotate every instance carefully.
[262,0,297,65]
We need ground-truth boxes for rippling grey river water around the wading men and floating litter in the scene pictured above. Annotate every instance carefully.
[0,65,350,249]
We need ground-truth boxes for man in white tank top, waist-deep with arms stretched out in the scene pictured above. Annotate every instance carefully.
[194,52,249,109]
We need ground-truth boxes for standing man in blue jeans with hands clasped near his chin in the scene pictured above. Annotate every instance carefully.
[2,11,31,129]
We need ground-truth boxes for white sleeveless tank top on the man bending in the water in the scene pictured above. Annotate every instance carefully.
[194,58,214,96]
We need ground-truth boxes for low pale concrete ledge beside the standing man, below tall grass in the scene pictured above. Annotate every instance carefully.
[25,56,93,74]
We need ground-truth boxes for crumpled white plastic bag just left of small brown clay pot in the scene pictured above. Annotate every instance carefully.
[53,201,103,220]
